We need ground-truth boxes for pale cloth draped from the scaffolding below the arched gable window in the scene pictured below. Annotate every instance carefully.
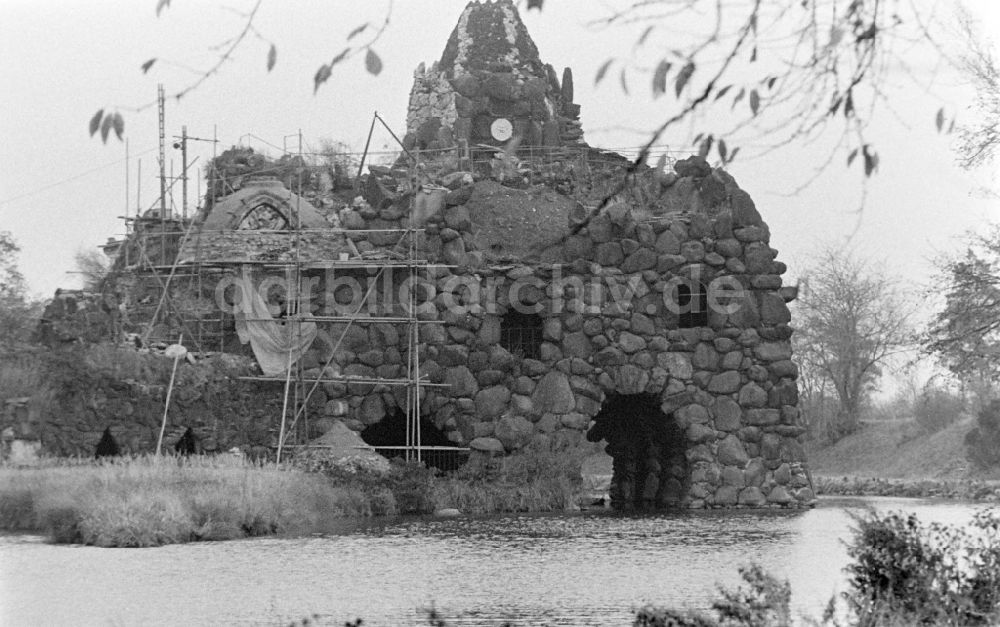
[233,266,316,376]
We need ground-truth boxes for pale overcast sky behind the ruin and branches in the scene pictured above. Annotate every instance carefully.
[0,0,1000,322]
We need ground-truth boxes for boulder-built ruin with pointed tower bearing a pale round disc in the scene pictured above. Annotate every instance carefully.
[29,0,814,508]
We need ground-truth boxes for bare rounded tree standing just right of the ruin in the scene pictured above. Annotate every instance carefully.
[795,248,913,440]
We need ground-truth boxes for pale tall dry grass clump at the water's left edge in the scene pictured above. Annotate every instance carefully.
[0,456,365,547]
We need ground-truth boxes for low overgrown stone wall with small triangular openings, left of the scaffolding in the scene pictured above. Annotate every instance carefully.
[0,345,282,457]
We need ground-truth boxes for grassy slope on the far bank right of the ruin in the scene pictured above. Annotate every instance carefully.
[808,417,998,480]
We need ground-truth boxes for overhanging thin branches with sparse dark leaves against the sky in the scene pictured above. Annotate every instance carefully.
[90,0,955,183]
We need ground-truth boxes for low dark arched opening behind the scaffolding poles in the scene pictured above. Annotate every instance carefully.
[361,407,468,472]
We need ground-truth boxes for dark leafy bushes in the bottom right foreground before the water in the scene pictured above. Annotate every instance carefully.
[633,510,1000,627]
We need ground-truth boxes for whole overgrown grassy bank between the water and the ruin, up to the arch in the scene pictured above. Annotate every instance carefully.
[0,452,580,547]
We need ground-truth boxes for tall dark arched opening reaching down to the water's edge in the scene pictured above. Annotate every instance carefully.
[587,393,688,509]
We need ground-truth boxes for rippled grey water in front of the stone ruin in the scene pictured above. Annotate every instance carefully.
[0,498,985,625]
